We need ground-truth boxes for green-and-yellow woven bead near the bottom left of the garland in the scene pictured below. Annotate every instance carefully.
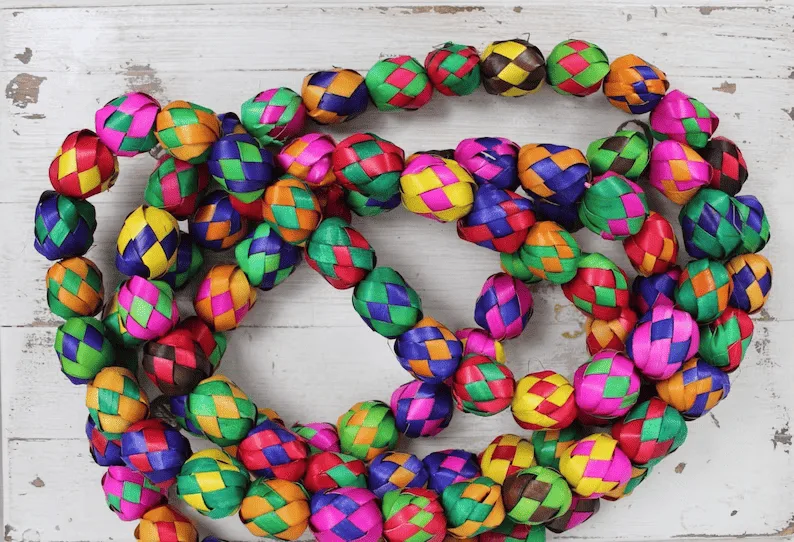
[176,449,250,519]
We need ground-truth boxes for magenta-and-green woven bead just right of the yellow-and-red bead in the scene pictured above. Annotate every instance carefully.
[573,350,640,418]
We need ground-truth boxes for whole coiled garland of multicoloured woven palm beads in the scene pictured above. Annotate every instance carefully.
[35,39,772,542]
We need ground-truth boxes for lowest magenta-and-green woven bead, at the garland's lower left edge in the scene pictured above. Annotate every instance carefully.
[102,467,167,521]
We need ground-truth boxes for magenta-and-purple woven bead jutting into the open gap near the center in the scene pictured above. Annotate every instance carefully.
[474,273,533,340]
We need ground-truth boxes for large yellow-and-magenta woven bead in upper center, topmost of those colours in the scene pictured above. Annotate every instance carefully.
[400,153,476,222]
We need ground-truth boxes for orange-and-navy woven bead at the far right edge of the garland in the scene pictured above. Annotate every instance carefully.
[725,254,772,314]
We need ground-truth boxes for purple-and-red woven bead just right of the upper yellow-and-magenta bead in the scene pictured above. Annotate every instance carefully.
[458,185,535,253]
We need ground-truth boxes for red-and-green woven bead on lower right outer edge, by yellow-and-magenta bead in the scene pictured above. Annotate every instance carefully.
[612,397,687,468]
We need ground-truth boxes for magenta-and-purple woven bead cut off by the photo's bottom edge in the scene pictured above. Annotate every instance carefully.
[309,487,383,542]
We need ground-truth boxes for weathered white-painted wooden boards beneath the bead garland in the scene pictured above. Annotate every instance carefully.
[0,0,794,542]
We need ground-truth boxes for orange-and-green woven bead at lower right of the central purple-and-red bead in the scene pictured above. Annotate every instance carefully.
[520,220,582,284]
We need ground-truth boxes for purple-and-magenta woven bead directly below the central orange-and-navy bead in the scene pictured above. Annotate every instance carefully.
[391,380,455,438]
